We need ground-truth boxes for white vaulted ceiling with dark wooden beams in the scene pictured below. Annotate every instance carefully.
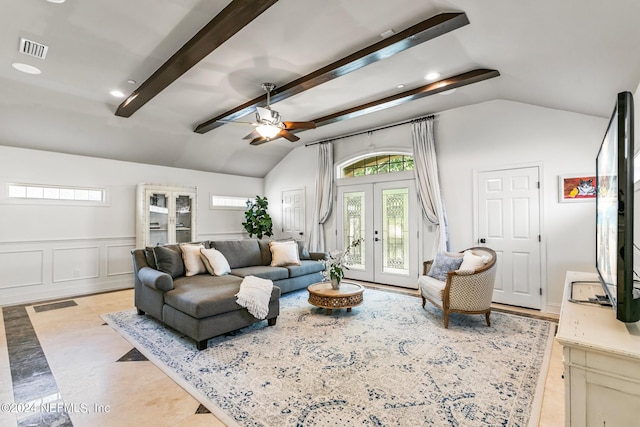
[0,0,640,177]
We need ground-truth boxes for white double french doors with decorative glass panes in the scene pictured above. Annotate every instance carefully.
[338,180,419,289]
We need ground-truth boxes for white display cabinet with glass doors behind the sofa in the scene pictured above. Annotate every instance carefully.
[136,184,197,248]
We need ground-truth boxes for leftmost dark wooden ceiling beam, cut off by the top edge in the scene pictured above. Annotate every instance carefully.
[116,0,278,117]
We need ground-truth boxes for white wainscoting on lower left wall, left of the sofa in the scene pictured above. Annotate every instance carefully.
[0,236,135,306]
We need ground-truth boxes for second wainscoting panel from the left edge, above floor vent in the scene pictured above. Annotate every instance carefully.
[53,246,100,283]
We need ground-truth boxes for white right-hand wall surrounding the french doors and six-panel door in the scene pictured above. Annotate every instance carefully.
[265,100,614,312]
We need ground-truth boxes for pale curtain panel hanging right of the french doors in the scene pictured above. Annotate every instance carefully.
[411,117,449,254]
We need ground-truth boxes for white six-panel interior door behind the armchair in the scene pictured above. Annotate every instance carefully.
[477,167,542,309]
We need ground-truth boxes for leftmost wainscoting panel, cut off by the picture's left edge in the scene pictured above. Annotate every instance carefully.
[0,249,44,289]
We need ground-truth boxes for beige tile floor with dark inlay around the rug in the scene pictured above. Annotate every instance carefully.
[0,289,564,427]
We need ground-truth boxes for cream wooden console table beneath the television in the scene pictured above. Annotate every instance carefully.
[556,271,640,427]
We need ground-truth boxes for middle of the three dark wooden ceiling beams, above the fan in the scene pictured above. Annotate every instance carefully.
[194,12,469,133]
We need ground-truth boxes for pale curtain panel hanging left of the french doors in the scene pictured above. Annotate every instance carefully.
[309,142,333,252]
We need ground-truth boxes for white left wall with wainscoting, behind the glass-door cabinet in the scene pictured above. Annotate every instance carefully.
[0,146,264,305]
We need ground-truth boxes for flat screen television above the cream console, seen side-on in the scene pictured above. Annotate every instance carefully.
[596,92,640,322]
